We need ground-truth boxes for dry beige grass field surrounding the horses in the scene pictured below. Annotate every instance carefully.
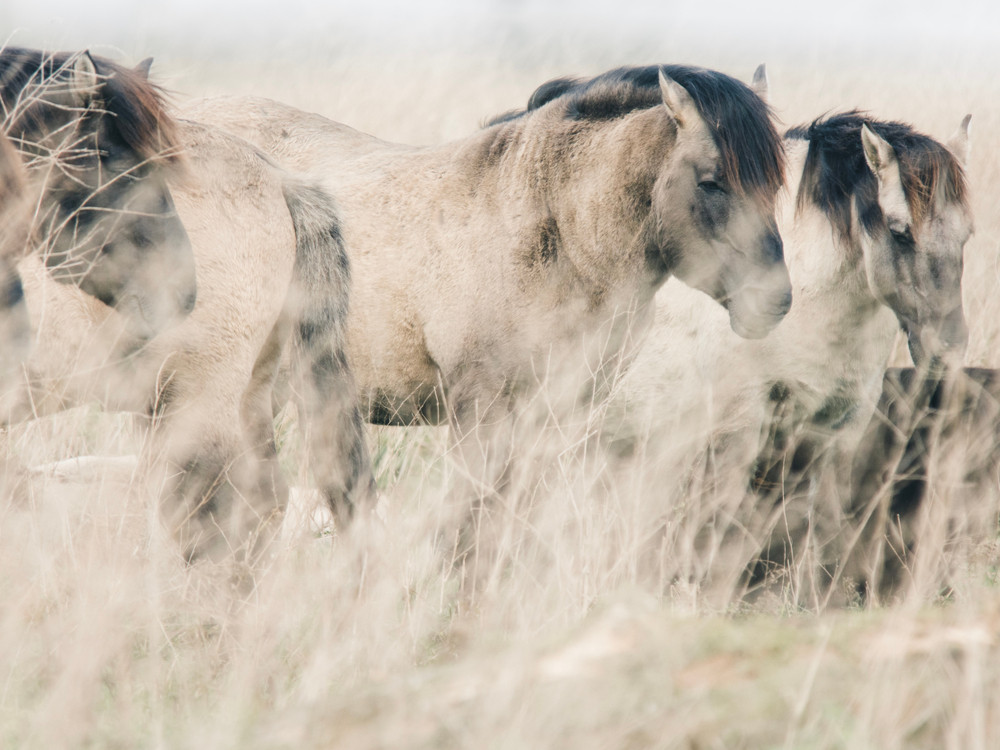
[0,8,1000,750]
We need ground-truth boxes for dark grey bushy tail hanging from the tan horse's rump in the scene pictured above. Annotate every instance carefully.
[283,177,375,527]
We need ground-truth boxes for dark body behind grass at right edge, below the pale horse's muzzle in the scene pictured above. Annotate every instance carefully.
[847,367,1000,603]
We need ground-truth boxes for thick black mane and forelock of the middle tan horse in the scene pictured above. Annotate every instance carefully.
[487,65,785,204]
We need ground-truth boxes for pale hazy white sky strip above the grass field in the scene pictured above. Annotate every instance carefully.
[0,0,1000,54]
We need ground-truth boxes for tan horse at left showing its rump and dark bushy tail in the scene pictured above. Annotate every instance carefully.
[20,111,374,561]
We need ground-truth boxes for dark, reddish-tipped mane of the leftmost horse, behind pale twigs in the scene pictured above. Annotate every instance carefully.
[0,47,179,163]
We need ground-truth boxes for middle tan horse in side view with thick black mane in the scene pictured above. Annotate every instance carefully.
[185,65,790,548]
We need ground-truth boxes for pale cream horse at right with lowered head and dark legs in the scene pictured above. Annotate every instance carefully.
[622,111,972,602]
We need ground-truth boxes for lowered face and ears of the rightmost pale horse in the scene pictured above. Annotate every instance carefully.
[860,116,972,367]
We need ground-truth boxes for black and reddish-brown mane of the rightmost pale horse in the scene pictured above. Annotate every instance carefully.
[785,110,969,240]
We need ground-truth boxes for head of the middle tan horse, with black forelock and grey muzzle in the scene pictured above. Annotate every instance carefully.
[653,66,792,338]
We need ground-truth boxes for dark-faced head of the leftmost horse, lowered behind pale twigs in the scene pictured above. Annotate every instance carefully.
[0,47,196,342]
